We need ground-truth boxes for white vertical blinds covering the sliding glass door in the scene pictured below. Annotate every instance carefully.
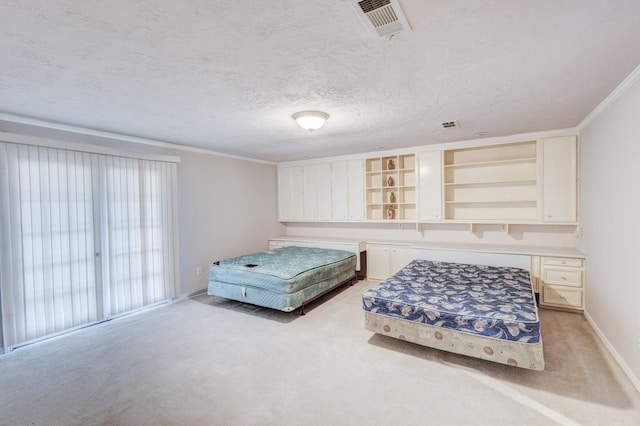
[0,142,177,353]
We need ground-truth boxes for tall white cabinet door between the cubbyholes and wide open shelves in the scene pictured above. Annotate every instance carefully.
[418,151,442,220]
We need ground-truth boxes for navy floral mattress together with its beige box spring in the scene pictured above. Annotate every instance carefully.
[362,260,544,370]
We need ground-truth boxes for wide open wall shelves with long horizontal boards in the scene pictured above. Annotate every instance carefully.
[444,141,537,222]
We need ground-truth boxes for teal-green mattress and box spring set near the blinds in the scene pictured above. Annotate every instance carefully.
[208,246,356,312]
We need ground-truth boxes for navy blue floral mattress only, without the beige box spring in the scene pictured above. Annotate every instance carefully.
[362,260,540,343]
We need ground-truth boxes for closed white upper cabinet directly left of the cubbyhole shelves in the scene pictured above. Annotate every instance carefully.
[331,159,364,220]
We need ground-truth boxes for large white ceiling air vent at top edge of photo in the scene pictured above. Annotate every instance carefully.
[353,0,411,37]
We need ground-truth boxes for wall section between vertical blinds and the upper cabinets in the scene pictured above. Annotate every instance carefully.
[176,152,284,293]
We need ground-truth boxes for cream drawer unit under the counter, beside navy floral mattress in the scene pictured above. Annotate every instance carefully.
[540,257,584,311]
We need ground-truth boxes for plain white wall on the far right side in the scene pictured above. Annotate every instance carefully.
[580,78,640,389]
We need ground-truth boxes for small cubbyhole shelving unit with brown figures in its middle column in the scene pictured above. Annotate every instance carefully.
[365,154,417,220]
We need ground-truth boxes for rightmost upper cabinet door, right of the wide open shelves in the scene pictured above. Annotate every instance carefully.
[541,136,577,223]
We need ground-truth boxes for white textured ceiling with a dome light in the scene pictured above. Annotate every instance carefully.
[0,0,640,161]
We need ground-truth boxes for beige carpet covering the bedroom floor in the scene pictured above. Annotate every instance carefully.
[0,281,640,426]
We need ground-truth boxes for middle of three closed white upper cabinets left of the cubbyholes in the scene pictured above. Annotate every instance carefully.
[303,163,331,220]
